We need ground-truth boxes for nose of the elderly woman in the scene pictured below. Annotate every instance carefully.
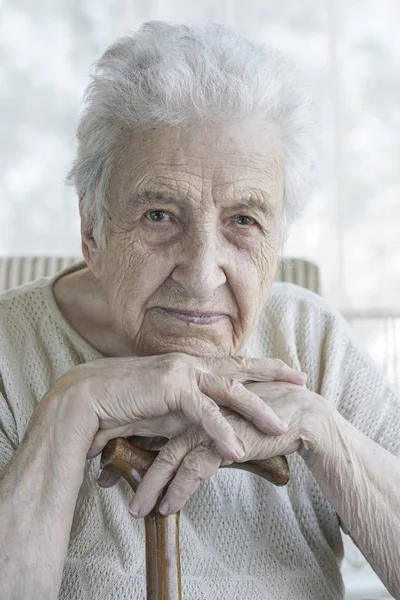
[172,230,226,299]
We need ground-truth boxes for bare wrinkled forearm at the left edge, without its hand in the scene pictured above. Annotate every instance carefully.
[0,394,86,600]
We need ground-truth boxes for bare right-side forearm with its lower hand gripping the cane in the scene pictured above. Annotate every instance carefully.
[123,383,400,599]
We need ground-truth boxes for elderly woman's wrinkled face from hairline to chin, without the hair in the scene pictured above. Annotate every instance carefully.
[91,121,284,356]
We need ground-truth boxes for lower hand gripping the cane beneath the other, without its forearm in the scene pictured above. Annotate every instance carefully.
[123,382,334,517]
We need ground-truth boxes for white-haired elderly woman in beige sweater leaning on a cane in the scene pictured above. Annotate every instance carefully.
[0,23,400,600]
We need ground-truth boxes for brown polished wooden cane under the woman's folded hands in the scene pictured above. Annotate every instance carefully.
[101,438,289,600]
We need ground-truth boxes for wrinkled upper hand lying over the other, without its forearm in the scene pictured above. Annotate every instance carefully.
[56,353,305,460]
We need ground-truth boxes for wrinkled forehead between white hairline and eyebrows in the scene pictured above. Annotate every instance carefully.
[110,124,283,213]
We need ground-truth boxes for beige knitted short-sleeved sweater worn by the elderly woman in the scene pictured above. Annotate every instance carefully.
[0,264,400,600]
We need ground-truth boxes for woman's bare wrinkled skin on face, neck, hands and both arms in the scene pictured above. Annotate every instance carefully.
[5,122,400,598]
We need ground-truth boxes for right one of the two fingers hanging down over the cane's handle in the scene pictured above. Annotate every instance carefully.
[159,444,222,515]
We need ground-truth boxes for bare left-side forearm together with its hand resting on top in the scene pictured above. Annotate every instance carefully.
[0,355,304,600]
